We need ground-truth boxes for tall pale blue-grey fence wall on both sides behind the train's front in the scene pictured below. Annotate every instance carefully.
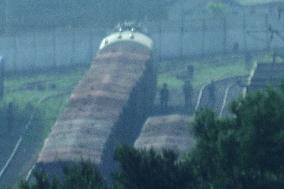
[0,11,284,71]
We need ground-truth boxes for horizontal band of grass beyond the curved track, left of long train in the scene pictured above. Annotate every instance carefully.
[3,68,86,105]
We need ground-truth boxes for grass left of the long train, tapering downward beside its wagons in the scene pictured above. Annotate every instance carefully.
[3,67,87,140]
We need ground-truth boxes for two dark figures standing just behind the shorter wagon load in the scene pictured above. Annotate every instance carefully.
[160,80,193,113]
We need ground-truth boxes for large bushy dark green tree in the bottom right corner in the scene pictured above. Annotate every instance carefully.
[190,88,284,189]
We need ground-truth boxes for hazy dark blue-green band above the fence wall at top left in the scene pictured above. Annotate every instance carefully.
[0,0,175,29]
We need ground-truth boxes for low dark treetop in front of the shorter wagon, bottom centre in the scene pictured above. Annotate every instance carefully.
[114,146,193,189]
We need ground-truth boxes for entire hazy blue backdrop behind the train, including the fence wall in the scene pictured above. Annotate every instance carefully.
[0,0,283,71]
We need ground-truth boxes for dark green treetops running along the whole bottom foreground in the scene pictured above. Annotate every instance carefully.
[20,86,284,189]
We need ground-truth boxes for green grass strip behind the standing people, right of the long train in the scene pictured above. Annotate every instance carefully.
[158,56,249,89]
